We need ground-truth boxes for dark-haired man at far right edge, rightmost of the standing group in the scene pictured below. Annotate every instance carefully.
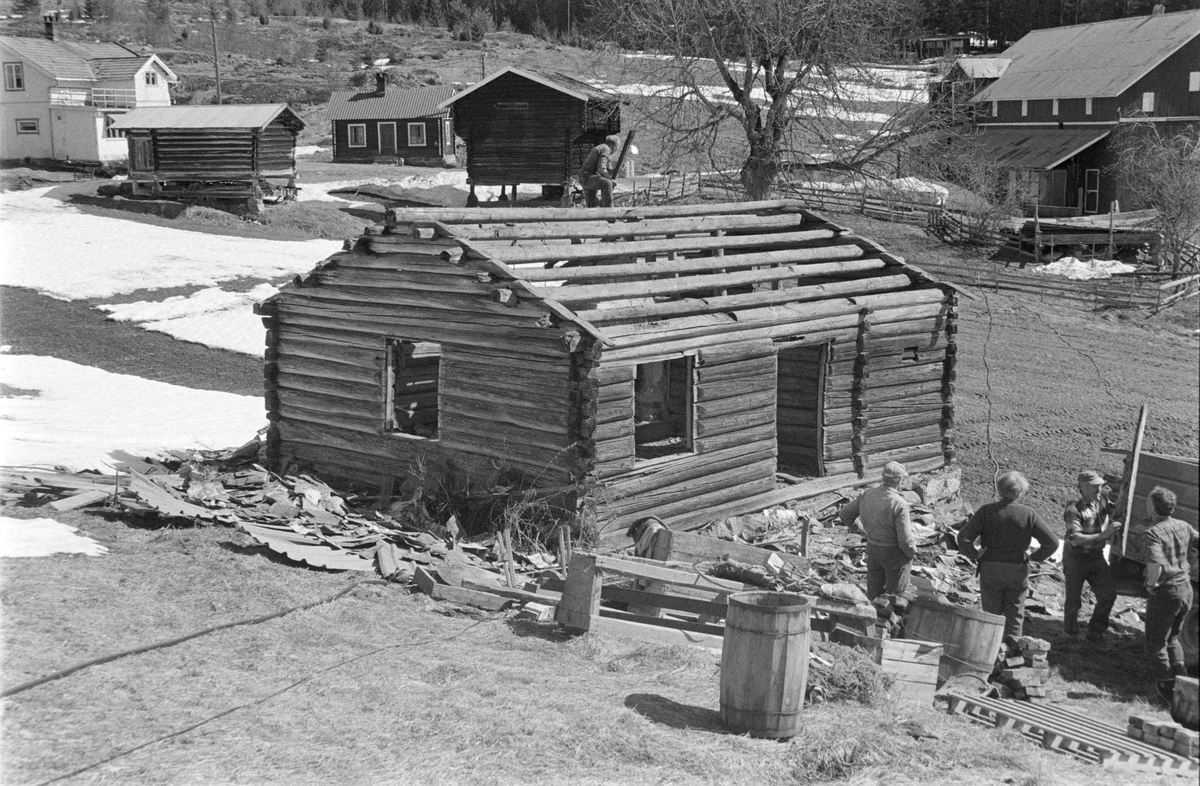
[1142,486,1196,703]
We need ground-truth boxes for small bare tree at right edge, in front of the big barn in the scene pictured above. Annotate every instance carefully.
[1114,121,1200,275]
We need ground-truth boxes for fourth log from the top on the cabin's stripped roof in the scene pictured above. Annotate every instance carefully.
[517,246,863,282]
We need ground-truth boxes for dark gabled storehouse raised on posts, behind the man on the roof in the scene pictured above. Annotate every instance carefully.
[442,67,620,206]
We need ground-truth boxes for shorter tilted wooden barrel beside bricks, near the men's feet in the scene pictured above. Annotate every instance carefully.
[904,598,1004,683]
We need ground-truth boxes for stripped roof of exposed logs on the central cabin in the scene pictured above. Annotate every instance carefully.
[272,200,950,347]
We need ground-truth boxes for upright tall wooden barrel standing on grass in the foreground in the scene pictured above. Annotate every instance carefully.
[721,592,811,739]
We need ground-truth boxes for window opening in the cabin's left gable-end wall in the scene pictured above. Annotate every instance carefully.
[384,338,442,439]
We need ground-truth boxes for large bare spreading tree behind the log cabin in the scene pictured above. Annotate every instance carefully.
[593,0,924,199]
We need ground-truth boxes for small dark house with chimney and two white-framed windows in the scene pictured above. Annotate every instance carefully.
[329,73,455,166]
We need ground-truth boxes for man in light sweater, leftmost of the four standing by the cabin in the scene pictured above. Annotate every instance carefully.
[838,461,917,600]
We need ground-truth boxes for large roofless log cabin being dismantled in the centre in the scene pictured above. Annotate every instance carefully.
[259,200,956,538]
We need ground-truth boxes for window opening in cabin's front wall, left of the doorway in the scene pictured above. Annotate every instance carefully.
[634,356,695,460]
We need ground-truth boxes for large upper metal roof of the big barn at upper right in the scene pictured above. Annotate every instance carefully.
[976,11,1200,101]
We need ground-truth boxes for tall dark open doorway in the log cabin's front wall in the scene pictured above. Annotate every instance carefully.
[775,344,829,478]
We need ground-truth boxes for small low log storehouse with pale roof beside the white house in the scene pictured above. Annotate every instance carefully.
[113,103,305,208]
